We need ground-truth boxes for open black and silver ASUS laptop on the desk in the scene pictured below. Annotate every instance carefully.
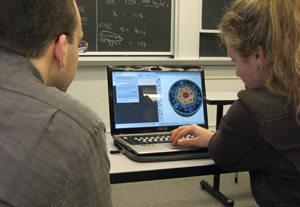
[107,66,208,155]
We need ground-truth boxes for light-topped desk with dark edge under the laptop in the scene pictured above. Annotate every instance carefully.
[106,133,225,184]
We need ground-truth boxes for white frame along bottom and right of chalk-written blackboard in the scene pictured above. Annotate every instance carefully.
[79,0,178,58]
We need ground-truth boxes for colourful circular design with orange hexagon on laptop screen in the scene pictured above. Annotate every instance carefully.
[169,80,202,117]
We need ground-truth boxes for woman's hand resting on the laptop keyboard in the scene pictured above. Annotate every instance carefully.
[170,124,214,148]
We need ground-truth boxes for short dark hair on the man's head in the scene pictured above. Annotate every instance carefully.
[0,0,77,58]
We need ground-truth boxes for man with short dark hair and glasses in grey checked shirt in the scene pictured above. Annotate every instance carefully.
[0,0,112,207]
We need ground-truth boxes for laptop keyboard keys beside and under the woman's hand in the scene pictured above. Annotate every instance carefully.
[122,134,193,145]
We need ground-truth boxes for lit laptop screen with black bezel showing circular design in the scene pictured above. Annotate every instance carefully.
[108,66,207,133]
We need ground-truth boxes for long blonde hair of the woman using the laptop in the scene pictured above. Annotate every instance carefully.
[219,0,300,124]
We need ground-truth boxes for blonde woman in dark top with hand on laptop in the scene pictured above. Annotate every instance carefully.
[171,0,300,206]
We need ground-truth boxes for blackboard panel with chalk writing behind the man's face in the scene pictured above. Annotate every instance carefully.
[77,0,173,54]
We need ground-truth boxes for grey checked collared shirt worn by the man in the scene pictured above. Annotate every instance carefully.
[0,49,112,207]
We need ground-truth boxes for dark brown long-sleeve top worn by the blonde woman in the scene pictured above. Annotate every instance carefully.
[209,89,300,207]
